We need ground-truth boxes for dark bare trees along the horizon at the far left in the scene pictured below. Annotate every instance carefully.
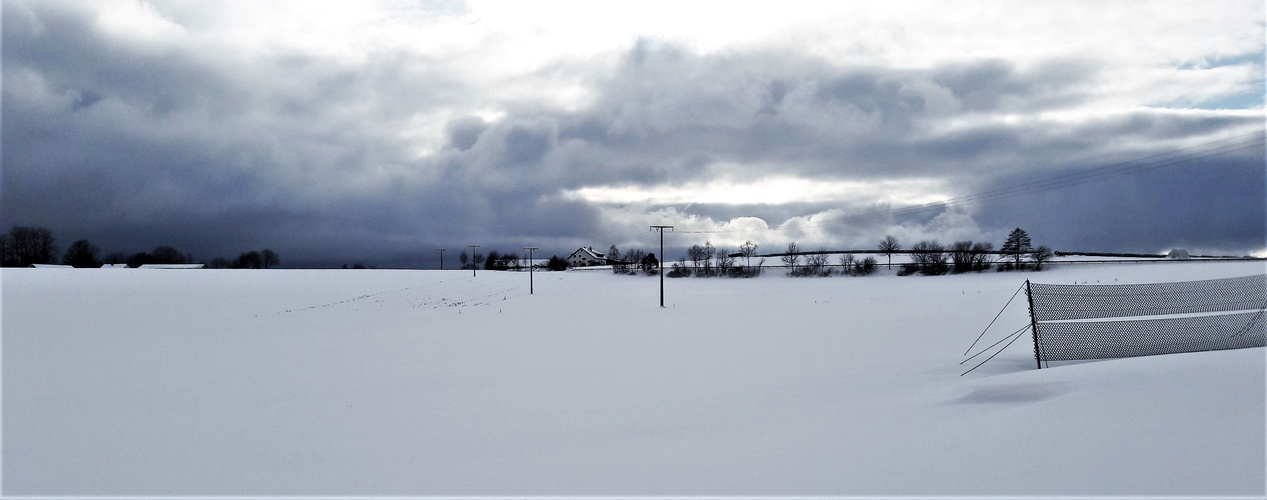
[0,225,281,270]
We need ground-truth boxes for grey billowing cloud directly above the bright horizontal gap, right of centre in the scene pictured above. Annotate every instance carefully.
[544,43,1109,182]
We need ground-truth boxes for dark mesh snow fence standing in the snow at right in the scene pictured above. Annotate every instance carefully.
[1030,275,1267,362]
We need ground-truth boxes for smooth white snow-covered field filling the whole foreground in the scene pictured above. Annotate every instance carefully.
[0,259,1267,496]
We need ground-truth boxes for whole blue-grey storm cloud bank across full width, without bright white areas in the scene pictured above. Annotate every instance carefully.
[3,3,1263,266]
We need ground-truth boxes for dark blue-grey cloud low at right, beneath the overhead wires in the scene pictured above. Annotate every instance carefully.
[979,134,1267,256]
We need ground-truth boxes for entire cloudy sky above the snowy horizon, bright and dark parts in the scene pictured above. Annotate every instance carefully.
[0,0,1267,267]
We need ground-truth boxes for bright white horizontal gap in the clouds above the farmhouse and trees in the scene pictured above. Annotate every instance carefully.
[564,177,952,205]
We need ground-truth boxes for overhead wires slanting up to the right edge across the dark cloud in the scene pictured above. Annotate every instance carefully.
[679,130,1264,234]
